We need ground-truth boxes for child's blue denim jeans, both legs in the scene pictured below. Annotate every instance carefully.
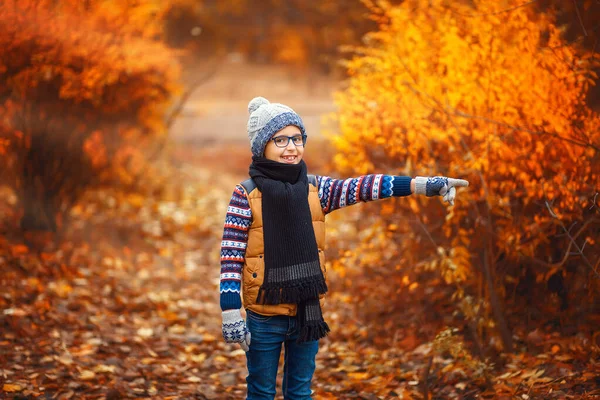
[246,311,319,400]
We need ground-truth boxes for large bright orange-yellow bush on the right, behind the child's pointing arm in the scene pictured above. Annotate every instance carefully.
[332,0,600,351]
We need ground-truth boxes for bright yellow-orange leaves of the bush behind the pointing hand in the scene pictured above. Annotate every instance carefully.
[333,0,600,298]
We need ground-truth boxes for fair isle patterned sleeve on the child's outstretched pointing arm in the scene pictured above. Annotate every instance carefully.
[317,174,412,214]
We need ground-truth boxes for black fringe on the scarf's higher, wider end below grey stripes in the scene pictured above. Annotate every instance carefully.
[256,280,328,304]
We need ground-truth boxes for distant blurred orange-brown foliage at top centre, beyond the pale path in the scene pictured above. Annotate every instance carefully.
[167,0,375,71]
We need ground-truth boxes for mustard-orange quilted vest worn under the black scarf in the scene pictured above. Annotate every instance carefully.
[242,175,327,316]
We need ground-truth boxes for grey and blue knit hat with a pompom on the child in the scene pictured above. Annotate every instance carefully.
[248,97,306,157]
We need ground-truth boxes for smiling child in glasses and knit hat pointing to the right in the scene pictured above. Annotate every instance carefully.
[220,97,468,399]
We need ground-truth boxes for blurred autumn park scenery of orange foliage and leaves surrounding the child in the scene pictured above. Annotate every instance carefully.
[0,0,600,399]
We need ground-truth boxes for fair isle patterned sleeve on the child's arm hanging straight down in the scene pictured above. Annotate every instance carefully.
[219,185,252,311]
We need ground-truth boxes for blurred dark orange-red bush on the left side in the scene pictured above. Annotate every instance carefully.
[0,0,179,231]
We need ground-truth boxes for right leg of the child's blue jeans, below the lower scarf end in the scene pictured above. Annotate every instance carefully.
[283,324,319,400]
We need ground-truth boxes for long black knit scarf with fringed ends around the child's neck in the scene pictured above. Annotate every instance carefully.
[249,157,329,342]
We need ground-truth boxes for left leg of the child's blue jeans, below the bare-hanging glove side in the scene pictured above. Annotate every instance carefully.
[246,312,288,400]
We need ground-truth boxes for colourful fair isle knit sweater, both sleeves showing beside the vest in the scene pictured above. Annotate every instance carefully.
[220,174,412,311]
